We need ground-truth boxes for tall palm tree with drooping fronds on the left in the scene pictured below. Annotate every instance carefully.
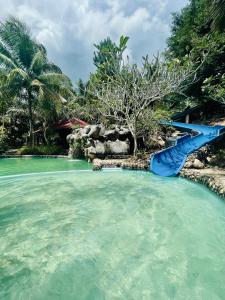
[0,17,73,145]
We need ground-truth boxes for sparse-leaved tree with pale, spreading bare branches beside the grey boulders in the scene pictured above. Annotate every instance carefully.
[90,57,195,156]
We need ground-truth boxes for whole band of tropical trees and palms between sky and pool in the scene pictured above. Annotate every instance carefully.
[0,0,225,155]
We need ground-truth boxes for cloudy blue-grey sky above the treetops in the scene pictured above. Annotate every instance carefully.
[0,0,188,82]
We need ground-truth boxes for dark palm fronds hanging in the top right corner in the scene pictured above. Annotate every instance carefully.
[211,0,225,31]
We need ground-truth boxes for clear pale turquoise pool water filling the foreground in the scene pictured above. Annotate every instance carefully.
[0,159,225,300]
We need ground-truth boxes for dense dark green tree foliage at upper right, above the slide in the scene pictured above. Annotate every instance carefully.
[167,0,225,102]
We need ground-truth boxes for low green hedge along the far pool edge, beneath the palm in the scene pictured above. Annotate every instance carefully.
[17,145,65,155]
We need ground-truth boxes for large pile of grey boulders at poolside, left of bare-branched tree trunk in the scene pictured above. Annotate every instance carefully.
[67,124,132,160]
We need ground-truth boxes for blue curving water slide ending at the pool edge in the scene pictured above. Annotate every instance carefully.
[149,122,225,176]
